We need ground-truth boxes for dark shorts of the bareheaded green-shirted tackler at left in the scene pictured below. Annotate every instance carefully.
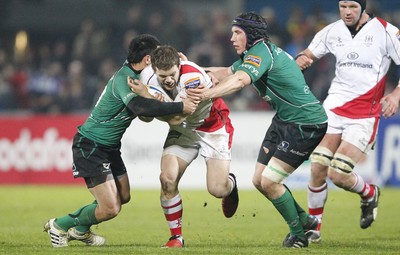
[72,133,126,178]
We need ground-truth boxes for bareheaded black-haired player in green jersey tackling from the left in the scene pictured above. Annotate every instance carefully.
[44,34,199,247]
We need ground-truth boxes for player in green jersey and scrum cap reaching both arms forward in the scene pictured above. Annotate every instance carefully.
[187,12,327,248]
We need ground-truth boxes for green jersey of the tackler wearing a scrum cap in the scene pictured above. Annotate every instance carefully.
[232,41,327,124]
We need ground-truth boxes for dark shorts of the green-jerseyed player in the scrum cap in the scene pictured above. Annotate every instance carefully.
[257,115,328,168]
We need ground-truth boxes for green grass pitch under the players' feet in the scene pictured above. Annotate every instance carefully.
[0,186,400,255]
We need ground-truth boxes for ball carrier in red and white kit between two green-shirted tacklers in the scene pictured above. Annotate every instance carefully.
[131,46,239,248]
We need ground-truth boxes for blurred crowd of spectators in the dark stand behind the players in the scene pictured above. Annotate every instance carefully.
[0,4,400,114]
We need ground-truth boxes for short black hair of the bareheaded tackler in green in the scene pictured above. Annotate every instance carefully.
[126,34,160,64]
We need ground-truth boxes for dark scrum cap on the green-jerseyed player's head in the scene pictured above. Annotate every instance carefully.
[232,12,268,50]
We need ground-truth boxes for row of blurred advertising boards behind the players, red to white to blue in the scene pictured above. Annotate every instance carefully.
[0,112,400,189]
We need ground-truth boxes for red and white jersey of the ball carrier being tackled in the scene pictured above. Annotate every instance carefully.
[140,61,229,132]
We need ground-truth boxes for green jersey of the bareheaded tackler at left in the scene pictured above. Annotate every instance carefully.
[78,65,140,146]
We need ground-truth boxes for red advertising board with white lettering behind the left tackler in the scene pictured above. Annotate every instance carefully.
[0,115,87,184]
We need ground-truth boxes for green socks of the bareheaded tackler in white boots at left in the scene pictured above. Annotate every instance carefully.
[55,202,99,232]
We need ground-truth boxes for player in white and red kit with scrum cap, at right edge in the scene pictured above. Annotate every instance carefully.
[296,0,400,242]
